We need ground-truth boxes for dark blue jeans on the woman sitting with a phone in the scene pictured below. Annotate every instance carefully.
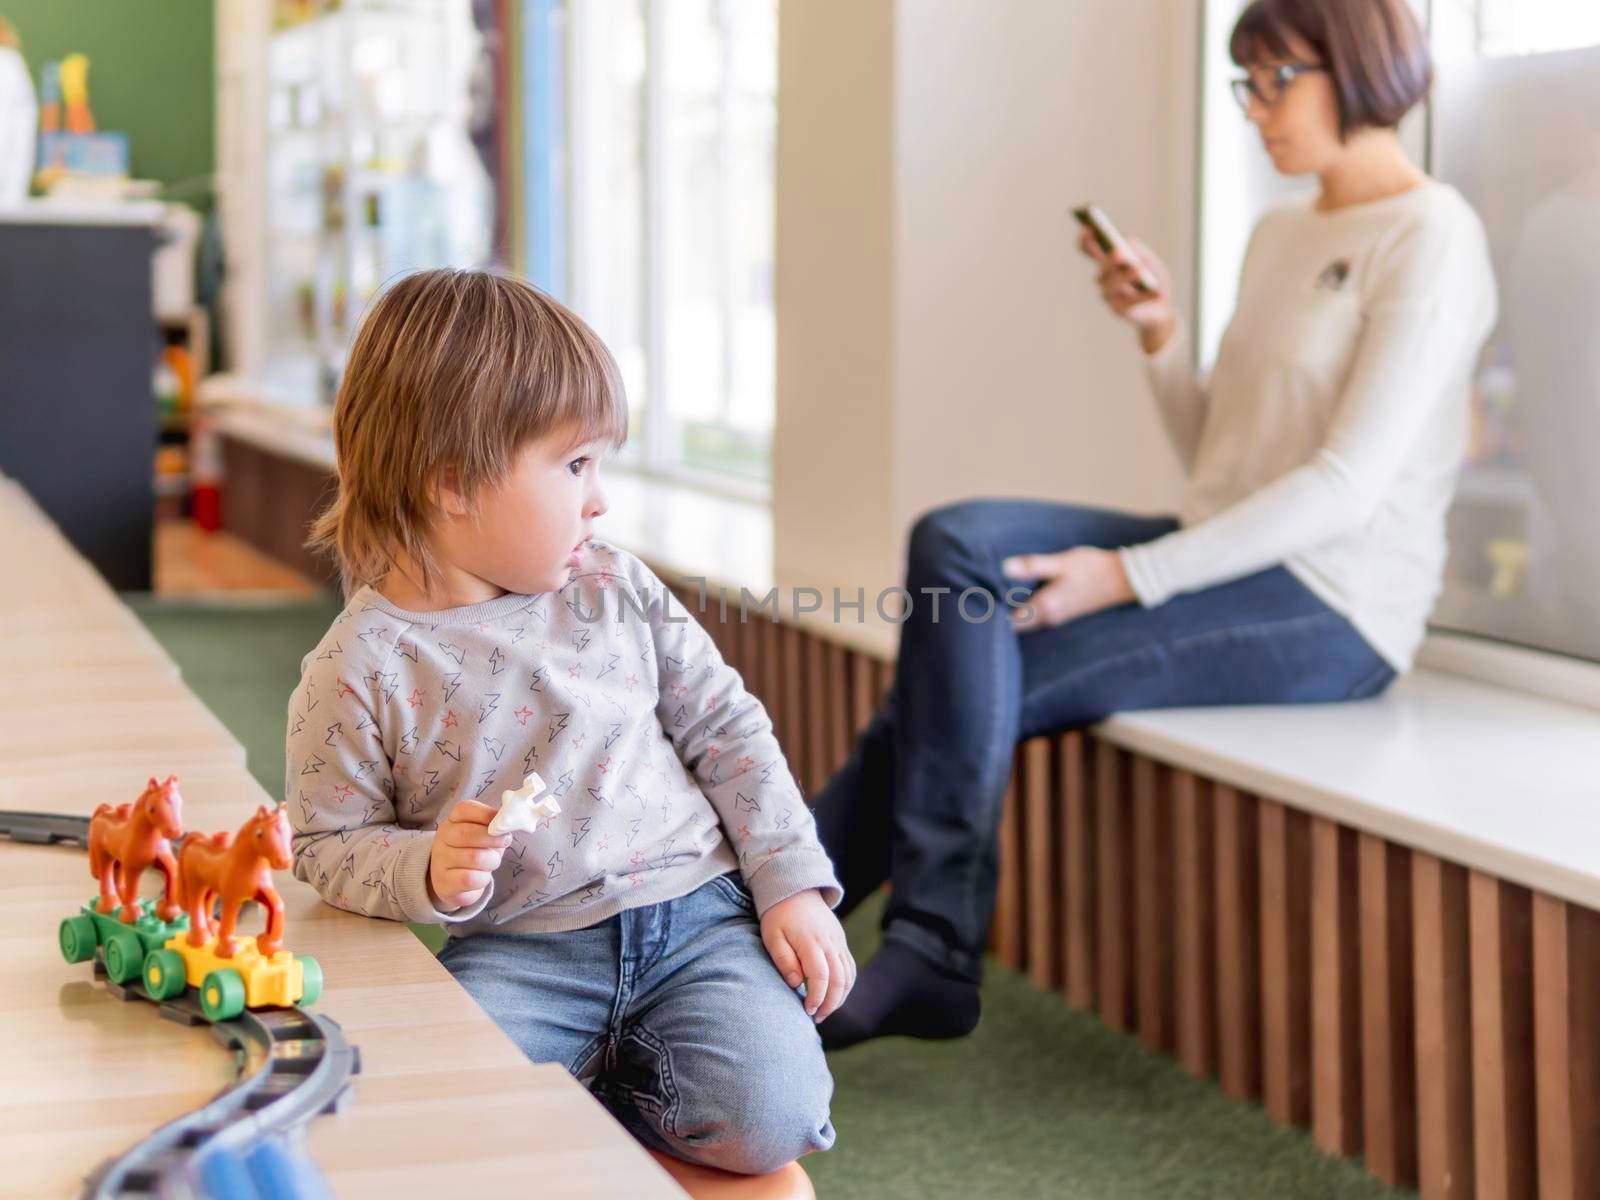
[816,501,1395,981]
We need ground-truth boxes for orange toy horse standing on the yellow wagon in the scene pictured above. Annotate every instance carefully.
[178,805,294,958]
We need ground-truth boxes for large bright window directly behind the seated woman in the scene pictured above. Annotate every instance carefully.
[1197,0,1600,659]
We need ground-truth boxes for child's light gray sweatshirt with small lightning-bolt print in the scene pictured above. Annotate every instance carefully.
[285,542,840,936]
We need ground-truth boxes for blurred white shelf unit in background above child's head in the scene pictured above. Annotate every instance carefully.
[218,0,494,405]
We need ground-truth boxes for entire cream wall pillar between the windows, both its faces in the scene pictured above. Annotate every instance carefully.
[774,0,1200,643]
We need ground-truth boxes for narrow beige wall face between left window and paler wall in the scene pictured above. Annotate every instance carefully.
[773,0,894,624]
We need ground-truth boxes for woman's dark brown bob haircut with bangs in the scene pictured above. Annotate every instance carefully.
[1227,0,1434,139]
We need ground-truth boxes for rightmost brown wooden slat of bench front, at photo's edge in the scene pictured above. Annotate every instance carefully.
[1533,893,1600,1200]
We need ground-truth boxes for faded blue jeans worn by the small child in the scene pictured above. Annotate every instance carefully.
[438,874,834,1174]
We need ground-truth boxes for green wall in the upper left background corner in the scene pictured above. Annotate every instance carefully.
[0,0,216,203]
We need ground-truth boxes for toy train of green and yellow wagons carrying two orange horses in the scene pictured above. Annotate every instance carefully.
[59,790,322,1021]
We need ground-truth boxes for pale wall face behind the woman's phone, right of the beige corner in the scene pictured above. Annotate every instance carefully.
[894,0,1197,531]
